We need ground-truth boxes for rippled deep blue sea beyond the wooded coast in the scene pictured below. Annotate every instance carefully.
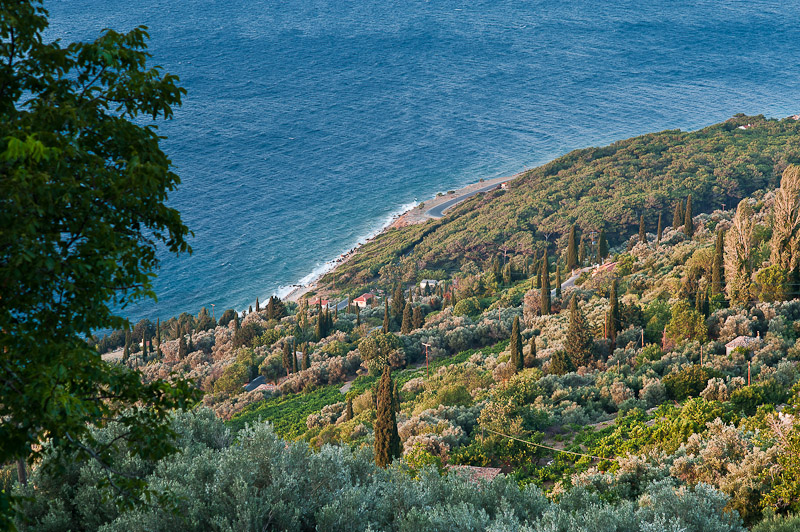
[45,0,800,320]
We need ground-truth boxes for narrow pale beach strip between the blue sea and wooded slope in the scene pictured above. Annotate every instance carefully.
[283,172,524,302]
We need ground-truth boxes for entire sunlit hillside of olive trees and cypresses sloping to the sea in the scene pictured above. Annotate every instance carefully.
[17,117,800,532]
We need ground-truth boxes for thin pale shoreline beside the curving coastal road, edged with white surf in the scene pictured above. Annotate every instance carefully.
[281,169,528,303]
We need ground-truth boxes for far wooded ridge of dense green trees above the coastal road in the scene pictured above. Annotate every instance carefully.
[321,115,800,291]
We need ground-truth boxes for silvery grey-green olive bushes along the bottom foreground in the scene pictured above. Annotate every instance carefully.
[10,410,743,532]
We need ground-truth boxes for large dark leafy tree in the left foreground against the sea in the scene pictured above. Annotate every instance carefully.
[0,0,199,527]
